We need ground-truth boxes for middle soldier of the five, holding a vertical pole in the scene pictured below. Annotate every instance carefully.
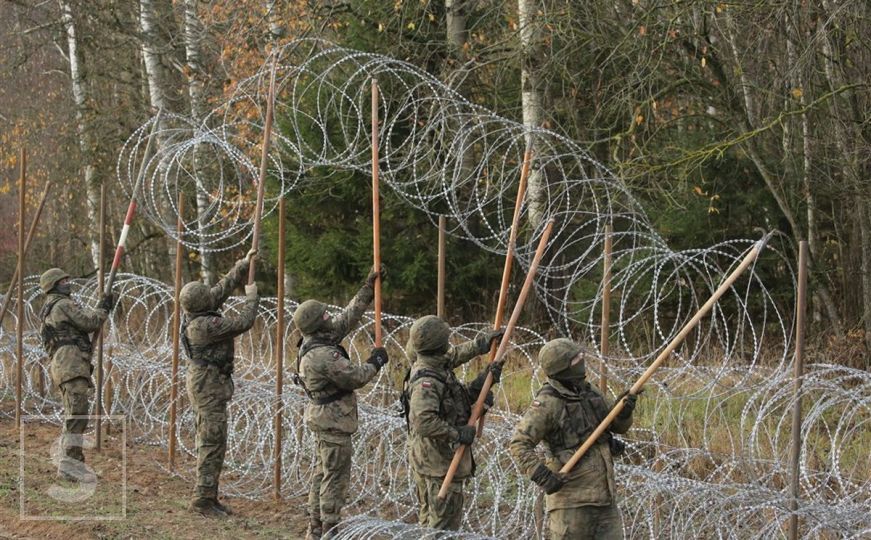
[293,266,388,539]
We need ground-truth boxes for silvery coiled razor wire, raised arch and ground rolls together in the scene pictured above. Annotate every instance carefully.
[0,40,871,538]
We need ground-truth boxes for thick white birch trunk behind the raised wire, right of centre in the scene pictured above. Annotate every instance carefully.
[517,0,546,227]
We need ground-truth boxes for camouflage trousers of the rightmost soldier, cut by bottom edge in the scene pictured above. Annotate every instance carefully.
[547,504,623,540]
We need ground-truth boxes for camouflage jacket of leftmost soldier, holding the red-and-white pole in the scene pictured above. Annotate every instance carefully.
[42,294,108,387]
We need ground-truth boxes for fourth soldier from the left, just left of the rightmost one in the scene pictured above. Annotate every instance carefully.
[405,315,504,531]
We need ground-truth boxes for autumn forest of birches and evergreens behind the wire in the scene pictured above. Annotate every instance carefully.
[0,0,871,360]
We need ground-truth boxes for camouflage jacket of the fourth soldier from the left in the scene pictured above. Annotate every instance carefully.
[408,341,490,479]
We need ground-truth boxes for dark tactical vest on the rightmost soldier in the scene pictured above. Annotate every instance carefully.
[536,383,610,456]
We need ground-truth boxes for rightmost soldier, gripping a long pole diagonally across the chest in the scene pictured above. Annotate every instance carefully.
[508,338,637,540]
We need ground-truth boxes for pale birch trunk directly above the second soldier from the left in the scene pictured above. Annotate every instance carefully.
[184,0,215,285]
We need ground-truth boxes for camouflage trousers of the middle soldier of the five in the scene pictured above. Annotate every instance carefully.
[308,433,354,524]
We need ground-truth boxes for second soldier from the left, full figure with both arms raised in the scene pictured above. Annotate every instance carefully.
[179,249,260,517]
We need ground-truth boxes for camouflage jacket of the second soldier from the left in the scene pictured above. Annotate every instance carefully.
[183,260,260,374]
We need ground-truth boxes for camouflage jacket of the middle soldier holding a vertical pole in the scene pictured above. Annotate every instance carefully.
[299,285,378,442]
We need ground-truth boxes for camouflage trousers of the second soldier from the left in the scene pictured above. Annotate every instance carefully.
[186,364,234,498]
